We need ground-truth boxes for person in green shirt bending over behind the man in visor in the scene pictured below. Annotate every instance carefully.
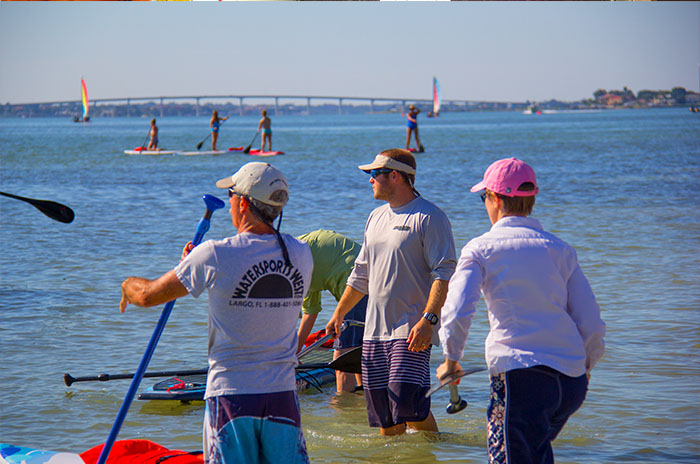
[297,229,367,393]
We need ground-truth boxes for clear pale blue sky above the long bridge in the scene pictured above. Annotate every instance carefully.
[0,2,700,104]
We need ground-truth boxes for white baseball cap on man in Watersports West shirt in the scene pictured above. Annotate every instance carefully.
[216,162,289,206]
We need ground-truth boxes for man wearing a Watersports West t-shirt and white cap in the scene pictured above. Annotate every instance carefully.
[120,163,313,464]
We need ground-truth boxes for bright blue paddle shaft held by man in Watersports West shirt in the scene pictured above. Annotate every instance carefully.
[97,195,224,464]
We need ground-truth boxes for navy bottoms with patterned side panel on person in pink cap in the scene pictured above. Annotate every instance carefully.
[486,366,588,464]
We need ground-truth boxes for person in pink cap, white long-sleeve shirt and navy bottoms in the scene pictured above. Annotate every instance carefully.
[437,158,605,463]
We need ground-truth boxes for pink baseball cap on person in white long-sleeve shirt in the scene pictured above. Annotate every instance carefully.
[471,158,539,197]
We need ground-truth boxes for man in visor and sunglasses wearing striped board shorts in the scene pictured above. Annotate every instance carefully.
[326,149,457,435]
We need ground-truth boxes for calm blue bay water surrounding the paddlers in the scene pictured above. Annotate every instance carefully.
[0,109,700,464]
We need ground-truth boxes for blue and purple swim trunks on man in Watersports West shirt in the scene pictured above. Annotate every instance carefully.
[204,391,309,464]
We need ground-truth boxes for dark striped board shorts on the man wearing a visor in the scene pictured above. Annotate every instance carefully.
[362,340,430,428]
